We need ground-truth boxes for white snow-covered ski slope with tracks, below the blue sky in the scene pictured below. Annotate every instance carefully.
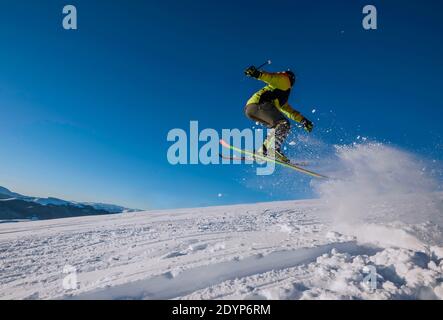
[0,200,443,299]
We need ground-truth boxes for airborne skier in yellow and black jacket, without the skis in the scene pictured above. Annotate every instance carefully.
[245,66,314,163]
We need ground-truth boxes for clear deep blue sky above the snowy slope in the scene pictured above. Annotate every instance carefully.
[0,0,443,209]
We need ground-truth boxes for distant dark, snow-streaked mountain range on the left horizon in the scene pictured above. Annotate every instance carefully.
[0,186,140,220]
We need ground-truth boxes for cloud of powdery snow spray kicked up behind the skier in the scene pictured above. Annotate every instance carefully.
[313,143,443,249]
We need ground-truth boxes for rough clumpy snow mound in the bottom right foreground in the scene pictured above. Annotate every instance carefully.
[182,247,443,300]
